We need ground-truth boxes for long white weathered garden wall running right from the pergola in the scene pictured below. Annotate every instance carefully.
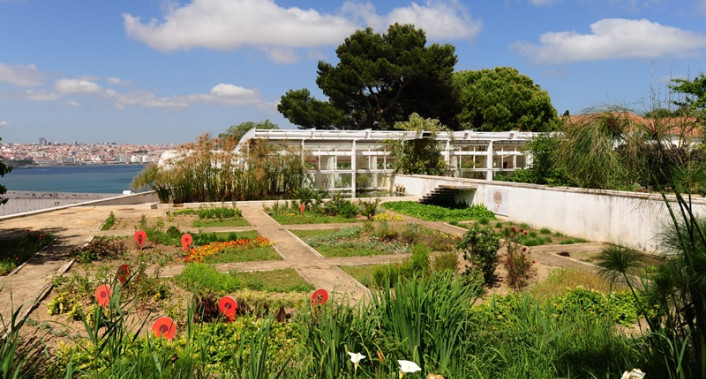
[395,175,706,252]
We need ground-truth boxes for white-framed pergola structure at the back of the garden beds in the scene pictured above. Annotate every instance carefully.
[236,129,536,196]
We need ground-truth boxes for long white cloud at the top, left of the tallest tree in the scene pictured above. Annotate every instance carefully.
[123,0,356,51]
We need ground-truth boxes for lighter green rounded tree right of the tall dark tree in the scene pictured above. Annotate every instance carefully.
[453,67,558,132]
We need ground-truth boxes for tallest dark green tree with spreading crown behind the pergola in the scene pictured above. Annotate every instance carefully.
[277,24,457,129]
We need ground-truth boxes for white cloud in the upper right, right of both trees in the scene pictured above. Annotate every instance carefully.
[512,18,706,63]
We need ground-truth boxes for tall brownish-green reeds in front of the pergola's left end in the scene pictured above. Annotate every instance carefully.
[133,135,304,203]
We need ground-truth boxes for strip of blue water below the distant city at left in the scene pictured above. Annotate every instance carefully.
[0,164,145,194]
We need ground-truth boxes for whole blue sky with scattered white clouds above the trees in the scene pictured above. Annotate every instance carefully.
[0,0,706,144]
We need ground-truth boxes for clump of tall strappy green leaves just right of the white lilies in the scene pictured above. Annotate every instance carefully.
[371,271,482,378]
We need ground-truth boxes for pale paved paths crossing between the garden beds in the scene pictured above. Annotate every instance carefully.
[0,202,604,329]
